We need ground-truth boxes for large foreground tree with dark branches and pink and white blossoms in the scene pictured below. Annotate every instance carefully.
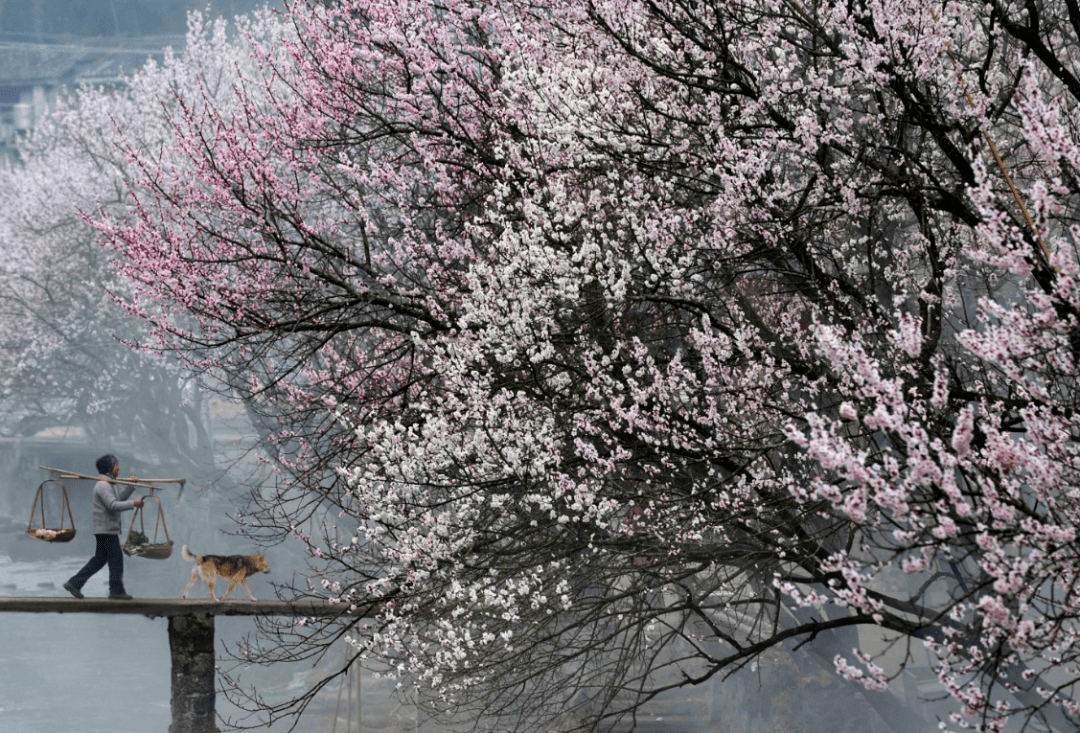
[90,0,1080,732]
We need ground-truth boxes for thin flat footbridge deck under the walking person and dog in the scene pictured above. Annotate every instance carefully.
[0,596,358,619]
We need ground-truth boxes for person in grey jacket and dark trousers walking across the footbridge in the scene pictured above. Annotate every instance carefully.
[64,453,143,600]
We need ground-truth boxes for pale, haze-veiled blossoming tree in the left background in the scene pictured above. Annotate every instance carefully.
[0,10,287,475]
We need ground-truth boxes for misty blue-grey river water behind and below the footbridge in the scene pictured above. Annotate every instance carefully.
[0,470,954,733]
